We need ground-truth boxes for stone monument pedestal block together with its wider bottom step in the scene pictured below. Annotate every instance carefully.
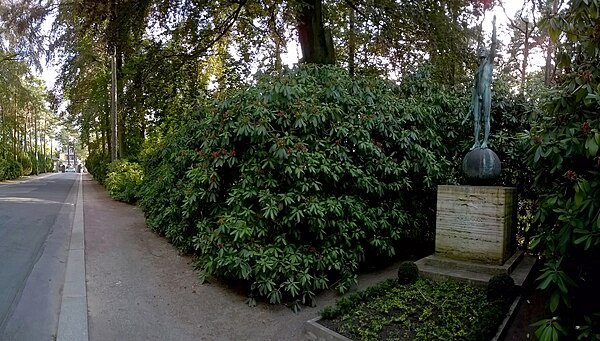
[416,186,537,286]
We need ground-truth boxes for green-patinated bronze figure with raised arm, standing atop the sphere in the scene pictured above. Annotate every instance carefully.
[471,16,496,150]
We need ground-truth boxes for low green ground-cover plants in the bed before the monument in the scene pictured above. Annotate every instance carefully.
[319,279,510,341]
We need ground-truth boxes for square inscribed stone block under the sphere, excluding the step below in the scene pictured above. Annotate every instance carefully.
[435,186,517,265]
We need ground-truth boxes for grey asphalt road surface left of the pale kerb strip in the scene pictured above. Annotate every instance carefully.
[0,173,79,341]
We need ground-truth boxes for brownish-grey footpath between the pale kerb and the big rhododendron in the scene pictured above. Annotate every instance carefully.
[83,174,404,341]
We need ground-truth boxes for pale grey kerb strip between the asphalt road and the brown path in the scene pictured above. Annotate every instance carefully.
[56,173,89,341]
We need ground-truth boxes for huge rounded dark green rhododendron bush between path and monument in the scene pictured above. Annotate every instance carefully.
[140,66,449,302]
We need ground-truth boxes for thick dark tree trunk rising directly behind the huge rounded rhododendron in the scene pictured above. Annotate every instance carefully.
[297,0,335,64]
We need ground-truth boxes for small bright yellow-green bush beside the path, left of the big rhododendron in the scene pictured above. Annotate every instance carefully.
[105,160,144,203]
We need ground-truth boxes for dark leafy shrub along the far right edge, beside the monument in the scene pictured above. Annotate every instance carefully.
[528,1,600,340]
